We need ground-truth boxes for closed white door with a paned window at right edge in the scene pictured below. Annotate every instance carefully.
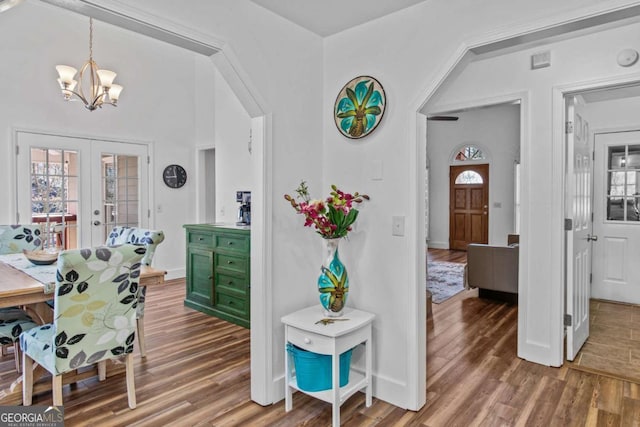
[592,131,640,304]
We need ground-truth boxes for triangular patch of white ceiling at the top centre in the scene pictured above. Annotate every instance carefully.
[251,0,428,37]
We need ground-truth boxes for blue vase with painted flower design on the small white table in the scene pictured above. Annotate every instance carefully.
[318,239,349,317]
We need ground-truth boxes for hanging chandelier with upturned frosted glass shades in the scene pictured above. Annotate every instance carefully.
[56,18,122,111]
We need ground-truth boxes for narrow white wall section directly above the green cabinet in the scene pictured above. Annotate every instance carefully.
[214,66,254,223]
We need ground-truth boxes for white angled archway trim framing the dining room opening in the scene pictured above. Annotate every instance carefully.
[39,0,274,405]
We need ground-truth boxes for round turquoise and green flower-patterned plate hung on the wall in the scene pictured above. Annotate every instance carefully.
[333,76,387,139]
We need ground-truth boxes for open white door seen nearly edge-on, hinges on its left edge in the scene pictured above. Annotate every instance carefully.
[565,96,593,360]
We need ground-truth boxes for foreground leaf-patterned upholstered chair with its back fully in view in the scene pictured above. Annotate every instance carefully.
[20,245,146,409]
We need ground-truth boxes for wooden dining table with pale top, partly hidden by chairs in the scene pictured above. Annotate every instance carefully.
[0,254,166,406]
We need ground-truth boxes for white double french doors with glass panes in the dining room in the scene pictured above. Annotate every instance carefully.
[16,131,149,249]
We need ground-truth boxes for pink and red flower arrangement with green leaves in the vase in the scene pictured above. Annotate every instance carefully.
[284,181,369,239]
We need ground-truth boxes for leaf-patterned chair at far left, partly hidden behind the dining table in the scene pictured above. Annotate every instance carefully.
[0,224,42,372]
